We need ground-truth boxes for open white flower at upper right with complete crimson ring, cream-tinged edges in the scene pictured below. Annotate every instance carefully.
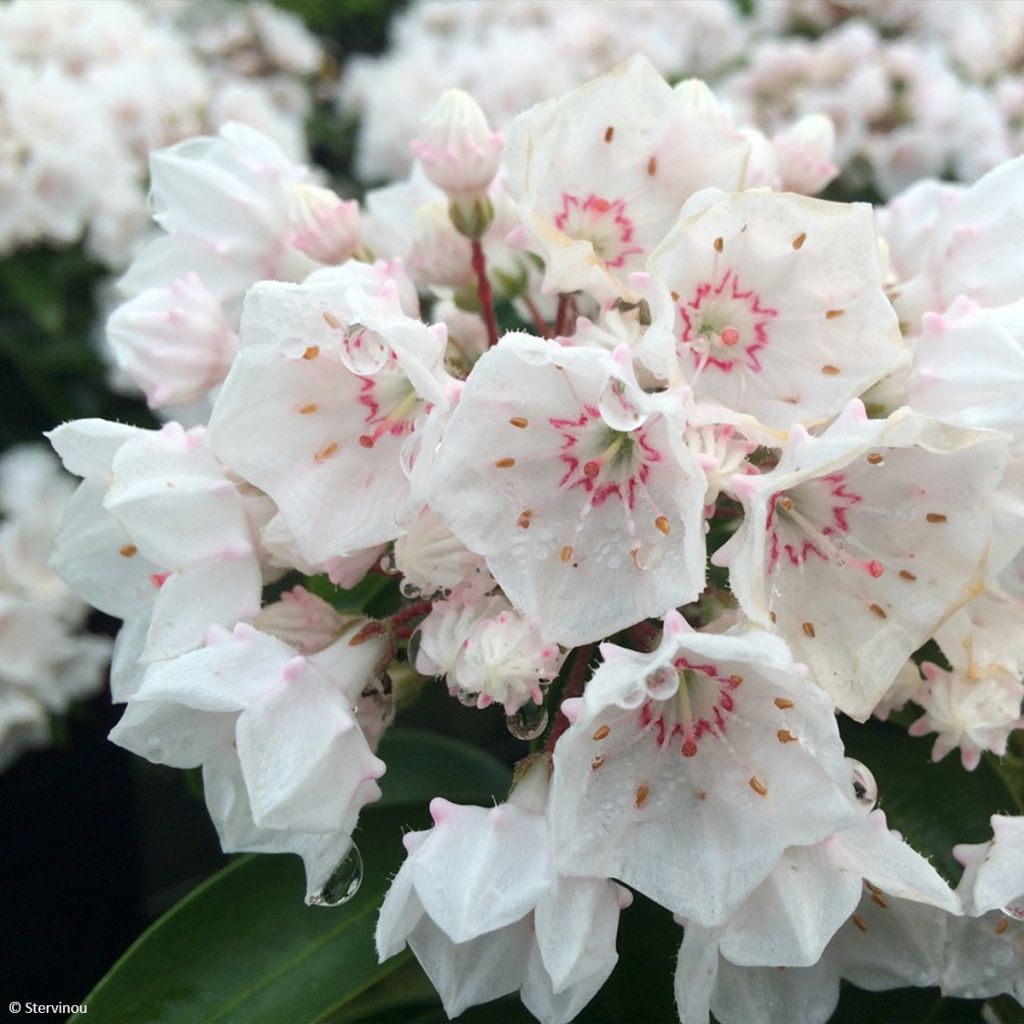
[647,189,907,428]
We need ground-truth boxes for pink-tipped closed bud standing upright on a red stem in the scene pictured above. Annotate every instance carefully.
[412,89,502,200]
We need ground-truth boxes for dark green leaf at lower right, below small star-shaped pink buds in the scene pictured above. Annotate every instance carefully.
[843,720,1022,881]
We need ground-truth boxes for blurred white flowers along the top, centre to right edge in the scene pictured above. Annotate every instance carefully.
[339,0,1024,197]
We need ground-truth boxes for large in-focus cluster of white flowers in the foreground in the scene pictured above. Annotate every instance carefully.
[44,59,1024,1024]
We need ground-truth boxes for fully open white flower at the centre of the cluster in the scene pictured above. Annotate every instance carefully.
[428,335,707,645]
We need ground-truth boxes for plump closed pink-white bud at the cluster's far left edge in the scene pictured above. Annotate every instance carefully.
[106,273,239,409]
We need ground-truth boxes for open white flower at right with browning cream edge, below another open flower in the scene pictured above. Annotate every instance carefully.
[716,401,1006,720]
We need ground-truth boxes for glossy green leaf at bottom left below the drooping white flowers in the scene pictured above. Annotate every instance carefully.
[73,730,510,1024]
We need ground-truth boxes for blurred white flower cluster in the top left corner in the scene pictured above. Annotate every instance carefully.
[0,0,322,267]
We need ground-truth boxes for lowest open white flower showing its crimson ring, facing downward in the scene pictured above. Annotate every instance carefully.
[551,611,857,925]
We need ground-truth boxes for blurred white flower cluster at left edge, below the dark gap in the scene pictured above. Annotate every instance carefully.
[0,445,111,770]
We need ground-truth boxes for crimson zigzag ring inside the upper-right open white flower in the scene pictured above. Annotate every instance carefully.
[679,268,778,373]
